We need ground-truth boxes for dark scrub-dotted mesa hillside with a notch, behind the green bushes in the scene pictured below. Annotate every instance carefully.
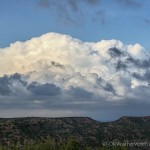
[0,116,150,149]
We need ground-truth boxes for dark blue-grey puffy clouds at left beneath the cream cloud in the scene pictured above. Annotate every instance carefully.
[0,73,61,96]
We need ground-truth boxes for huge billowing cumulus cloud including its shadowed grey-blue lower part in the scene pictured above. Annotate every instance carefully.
[0,33,150,119]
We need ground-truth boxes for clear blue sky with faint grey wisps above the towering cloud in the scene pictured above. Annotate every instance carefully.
[0,0,150,49]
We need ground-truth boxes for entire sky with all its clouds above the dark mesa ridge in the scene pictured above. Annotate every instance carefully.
[0,0,150,121]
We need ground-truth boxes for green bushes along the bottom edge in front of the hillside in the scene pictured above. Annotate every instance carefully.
[0,137,127,150]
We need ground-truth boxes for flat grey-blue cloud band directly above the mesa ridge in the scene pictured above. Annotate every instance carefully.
[0,97,150,121]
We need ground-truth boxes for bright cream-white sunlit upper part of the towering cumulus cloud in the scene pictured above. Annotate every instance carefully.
[0,33,149,95]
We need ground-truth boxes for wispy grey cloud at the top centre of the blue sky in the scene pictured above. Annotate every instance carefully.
[37,0,105,25]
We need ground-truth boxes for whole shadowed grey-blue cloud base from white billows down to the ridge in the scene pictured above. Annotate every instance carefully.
[0,73,150,121]
